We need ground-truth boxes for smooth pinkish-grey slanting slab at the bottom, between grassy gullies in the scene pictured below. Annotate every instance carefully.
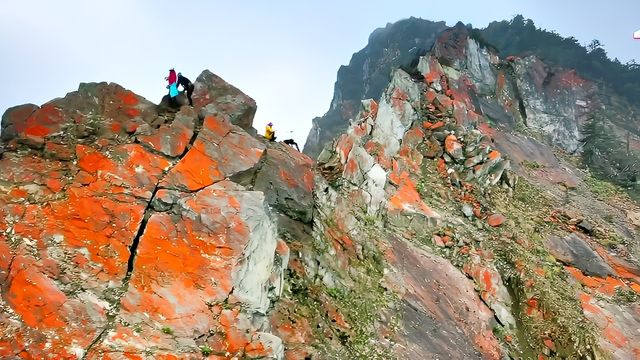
[390,238,501,359]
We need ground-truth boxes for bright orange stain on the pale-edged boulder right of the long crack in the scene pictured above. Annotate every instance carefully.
[109,187,268,355]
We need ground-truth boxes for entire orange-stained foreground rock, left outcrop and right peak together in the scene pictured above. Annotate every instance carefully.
[0,21,640,360]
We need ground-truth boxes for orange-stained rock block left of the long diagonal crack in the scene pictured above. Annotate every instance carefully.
[0,144,169,358]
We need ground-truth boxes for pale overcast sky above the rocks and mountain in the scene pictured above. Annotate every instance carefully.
[0,0,640,146]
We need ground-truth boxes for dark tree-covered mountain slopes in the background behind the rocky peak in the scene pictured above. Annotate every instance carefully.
[304,15,640,162]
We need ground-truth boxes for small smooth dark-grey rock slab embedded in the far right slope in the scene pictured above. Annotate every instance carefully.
[545,233,615,278]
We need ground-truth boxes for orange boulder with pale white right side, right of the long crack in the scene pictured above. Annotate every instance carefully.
[90,182,286,358]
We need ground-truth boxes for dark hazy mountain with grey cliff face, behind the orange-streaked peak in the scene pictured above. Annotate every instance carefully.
[304,16,640,163]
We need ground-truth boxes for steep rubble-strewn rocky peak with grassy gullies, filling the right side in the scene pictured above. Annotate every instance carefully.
[288,24,640,359]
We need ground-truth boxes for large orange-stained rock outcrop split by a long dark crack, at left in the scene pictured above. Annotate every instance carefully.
[0,72,290,359]
